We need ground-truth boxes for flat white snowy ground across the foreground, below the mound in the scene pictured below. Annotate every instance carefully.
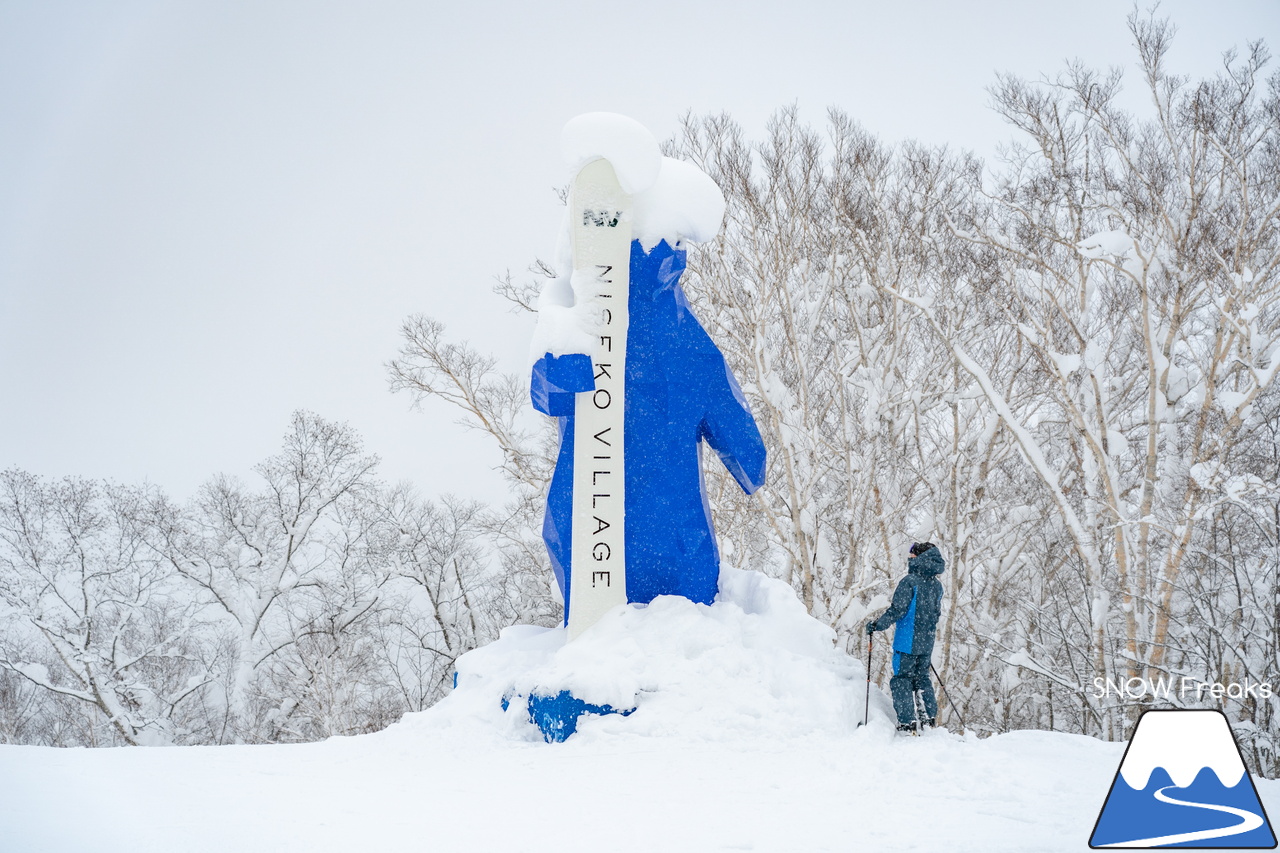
[0,719,1162,853]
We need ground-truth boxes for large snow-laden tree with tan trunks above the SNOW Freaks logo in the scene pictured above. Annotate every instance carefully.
[921,8,1280,735]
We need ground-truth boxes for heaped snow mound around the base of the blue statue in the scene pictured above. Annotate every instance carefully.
[415,567,890,743]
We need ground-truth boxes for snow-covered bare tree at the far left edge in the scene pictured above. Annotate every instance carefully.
[0,470,211,744]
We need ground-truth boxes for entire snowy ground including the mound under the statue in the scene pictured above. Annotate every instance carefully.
[0,570,1280,853]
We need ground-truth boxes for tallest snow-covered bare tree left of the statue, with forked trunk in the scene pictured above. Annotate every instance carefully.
[145,412,378,742]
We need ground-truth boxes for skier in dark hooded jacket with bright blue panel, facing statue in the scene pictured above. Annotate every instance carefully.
[867,542,946,731]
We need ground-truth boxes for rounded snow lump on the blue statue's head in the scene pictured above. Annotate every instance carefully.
[632,158,724,251]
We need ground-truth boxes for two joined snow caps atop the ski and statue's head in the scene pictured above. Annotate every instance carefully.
[561,113,724,251]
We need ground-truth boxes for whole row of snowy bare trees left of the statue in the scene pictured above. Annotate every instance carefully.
[0,412,529,745]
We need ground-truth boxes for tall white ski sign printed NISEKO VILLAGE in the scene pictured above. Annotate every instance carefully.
[568,160,631,640]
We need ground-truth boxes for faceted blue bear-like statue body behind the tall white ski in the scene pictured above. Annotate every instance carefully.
[531,240,765,614]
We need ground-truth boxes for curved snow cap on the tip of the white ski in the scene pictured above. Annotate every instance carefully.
[561,113,662,195]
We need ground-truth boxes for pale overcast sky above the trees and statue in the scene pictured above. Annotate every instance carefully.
[0,0,1280,500]
